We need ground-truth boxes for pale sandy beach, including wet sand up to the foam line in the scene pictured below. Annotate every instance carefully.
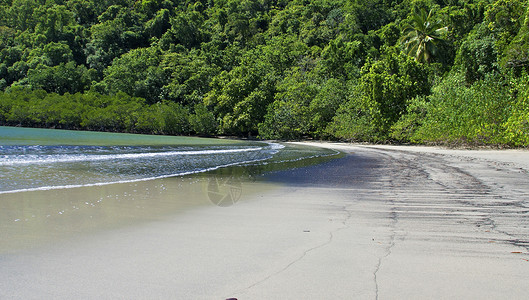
[0,143,529,300]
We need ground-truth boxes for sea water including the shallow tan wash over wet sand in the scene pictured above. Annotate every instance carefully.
[0,127,338,253]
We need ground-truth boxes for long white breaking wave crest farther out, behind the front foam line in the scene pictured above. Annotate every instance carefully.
[0,147,263,166]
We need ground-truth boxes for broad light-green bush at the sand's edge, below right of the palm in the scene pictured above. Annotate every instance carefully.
[413,73,513,145]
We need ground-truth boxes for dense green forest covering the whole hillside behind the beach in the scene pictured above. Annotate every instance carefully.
[0,0,529,146]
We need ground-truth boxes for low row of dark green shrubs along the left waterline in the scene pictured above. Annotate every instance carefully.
[0,88,216,135]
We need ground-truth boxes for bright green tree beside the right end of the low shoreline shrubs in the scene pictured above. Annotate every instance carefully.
[205,36,307,134]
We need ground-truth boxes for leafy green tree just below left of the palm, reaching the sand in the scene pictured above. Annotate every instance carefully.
[331,50,430,141]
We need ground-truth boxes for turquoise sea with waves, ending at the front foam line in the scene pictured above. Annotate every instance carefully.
[0,127,337,194]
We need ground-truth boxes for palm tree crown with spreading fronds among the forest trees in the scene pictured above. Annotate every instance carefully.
[401,9,448,63]
